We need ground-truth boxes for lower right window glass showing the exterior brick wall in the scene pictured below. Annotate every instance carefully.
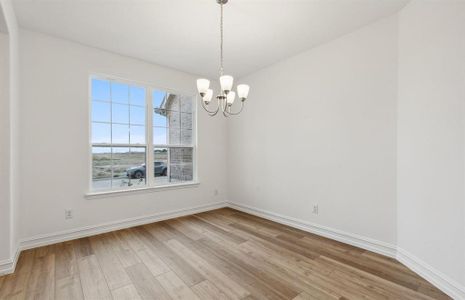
[169,148,194,182]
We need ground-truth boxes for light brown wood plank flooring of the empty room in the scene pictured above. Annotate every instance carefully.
[0,208,450,300]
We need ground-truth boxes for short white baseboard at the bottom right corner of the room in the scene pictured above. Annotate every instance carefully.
[396,247,465,300]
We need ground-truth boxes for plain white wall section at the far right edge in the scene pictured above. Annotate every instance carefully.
[397,1,465,293]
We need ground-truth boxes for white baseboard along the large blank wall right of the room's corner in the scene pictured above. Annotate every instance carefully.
[227,202,396,257]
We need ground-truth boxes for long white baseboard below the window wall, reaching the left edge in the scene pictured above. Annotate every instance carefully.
[0,202,226,275]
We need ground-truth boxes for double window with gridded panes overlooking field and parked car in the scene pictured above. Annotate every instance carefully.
[90,76,195,191]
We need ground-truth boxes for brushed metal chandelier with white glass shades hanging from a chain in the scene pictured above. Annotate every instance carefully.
[197,0,249,117]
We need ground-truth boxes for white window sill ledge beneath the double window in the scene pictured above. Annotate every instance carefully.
[84,181,200,199]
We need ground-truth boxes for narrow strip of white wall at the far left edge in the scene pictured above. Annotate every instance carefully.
[0,0,19,271]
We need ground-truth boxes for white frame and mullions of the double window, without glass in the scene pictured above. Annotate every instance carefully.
[86,73,199,197]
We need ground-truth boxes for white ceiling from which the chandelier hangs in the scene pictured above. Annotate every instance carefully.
[14,0,408,77]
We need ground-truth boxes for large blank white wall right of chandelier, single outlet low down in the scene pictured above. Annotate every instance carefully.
[228,16,397,244]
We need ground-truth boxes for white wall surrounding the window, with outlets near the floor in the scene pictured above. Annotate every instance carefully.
[19,31,227,239]
